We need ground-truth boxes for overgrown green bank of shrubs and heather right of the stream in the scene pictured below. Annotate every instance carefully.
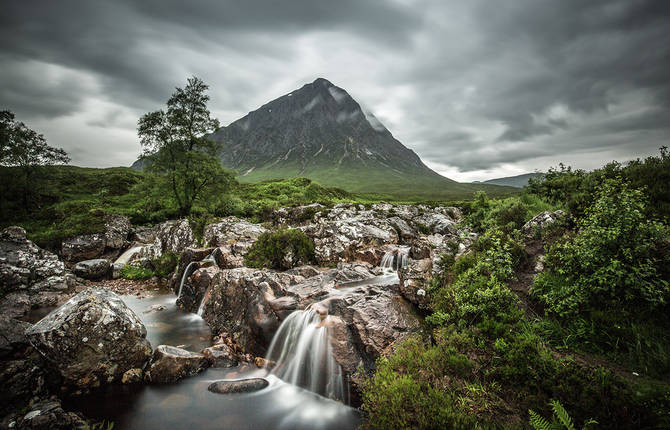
[363,148,670,429]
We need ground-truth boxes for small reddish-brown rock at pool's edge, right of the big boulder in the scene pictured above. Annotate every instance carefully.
[146,345,209,383]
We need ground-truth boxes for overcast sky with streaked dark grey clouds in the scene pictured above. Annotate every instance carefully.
[0,0,670,181]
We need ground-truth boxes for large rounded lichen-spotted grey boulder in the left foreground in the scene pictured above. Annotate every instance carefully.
[26,287,151,388]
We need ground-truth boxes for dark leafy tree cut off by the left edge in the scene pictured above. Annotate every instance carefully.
[0,110,70,211]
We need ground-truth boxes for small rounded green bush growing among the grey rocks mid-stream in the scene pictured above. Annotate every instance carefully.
[244,229,314,270]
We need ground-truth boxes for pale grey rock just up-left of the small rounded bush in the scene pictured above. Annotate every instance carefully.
[203,216,267,250]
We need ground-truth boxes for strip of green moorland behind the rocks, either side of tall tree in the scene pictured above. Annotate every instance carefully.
[0,162,513,249]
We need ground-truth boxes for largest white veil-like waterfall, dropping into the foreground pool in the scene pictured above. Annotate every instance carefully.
[268,308,349,403]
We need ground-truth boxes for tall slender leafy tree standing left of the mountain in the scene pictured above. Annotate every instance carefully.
[137,77,233,216]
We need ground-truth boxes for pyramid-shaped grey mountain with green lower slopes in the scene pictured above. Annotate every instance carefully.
[209,78,512,197]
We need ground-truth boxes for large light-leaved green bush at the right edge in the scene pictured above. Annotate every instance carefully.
[532,179,670,318]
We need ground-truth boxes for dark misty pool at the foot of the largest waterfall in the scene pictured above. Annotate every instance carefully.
[66,367,360,430]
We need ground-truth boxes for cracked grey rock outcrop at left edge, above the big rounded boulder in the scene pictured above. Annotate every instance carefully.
[0,227,75,317]
